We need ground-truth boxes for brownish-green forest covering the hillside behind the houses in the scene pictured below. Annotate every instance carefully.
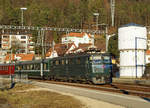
[0,0,150,55]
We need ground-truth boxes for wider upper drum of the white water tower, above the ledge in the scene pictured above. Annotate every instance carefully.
[118,24,147,50]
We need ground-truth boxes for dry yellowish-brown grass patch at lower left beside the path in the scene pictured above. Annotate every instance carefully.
[0,84,83,108]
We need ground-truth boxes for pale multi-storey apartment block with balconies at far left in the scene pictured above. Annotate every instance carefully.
[1,34,34,54]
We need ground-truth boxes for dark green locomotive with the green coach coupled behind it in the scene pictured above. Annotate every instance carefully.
[15,53,112,84]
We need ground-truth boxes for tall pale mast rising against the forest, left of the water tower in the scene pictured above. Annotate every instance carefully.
[110,0,115,27]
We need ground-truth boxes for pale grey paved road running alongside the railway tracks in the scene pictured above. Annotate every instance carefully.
[32,81,150,108]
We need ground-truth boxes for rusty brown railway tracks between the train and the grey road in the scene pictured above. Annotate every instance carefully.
[31,80,150,99]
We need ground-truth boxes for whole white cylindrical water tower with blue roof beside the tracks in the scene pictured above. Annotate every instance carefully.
[118,23,147,78]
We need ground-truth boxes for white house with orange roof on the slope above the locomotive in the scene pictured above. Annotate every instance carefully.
[61,32,94,47]
